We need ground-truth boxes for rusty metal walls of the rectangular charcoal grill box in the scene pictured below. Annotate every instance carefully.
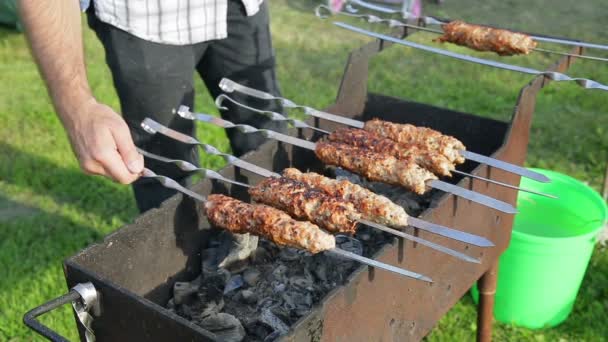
[65,28,584,341]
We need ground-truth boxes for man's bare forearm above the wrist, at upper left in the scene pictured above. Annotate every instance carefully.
[19,0,92,125]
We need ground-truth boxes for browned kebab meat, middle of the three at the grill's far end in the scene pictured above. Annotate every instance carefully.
[327,128,454,176]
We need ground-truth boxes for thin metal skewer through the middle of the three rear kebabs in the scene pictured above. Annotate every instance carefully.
[214,94,557,199]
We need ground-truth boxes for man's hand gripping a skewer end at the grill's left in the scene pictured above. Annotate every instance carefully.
[63,98,144,184]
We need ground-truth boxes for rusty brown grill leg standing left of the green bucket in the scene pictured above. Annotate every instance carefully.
[477,260,498,342]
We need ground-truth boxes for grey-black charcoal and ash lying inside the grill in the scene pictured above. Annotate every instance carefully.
[167,169,437,342]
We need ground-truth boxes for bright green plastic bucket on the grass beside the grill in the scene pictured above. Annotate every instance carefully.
[471,169,608,329]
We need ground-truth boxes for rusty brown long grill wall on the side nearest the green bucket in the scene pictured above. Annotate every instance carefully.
[286,42,580,341]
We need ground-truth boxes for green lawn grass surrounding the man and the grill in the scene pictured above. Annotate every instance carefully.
[0,0,608,341]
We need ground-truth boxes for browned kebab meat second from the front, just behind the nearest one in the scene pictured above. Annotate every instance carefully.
[249,177,361,234]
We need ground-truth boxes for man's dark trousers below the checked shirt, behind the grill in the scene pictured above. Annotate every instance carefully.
[88,0,285,212]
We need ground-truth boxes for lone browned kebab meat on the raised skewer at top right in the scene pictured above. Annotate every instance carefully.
[437,21,537,56]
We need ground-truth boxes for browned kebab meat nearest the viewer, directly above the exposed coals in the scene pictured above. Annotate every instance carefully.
[205,195,336,253]
